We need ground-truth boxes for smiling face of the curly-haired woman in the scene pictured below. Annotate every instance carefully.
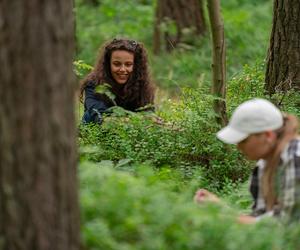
[110,50,134,84]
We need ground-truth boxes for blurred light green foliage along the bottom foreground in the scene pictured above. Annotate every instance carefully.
[80,162,300,250]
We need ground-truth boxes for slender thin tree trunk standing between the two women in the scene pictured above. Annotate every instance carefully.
[207,0,228,126]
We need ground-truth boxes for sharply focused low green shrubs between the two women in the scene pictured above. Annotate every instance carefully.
[79,91,250,189]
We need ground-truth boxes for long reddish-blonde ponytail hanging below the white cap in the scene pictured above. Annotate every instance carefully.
[261,115,299,211]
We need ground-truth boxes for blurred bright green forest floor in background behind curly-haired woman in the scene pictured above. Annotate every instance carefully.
[76,0,272,93]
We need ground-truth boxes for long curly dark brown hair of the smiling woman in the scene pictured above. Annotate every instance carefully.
[80,39,154,109]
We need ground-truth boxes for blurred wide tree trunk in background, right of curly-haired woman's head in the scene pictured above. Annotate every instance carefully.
[153,0,205,54]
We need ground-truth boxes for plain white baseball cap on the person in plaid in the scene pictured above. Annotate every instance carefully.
[217,98,283,144]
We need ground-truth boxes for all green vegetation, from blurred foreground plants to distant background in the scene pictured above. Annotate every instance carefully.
[74,0,300,250]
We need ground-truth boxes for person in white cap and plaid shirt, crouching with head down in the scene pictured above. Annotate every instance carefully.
[194,99,300,223]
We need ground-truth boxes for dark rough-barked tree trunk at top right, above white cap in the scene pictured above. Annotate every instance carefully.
[265,0,300,94]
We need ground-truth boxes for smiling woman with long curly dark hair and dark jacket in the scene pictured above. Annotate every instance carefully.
[80,39,154,124]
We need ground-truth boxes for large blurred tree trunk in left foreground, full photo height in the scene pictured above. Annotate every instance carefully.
[0,0,79,250]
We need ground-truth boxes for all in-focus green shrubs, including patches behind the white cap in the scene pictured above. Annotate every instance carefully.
[79,64,300,190]
